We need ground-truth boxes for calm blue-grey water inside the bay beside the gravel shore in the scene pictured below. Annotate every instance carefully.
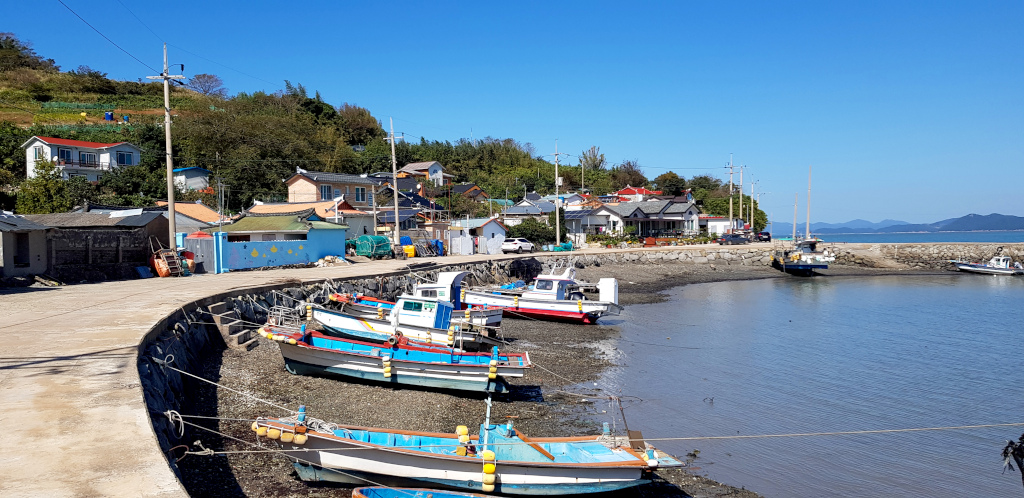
[600,274,1024,497]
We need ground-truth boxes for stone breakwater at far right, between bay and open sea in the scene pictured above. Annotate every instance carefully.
[831,243,1024,271]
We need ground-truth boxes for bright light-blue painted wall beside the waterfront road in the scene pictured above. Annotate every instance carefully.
[213,230,347,274]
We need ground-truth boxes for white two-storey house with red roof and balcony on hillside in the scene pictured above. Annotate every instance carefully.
[22,136,142,181]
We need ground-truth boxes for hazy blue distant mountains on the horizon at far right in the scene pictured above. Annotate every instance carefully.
[772,213,1024,235]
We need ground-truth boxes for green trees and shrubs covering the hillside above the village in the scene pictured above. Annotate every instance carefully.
[0,33,766,227]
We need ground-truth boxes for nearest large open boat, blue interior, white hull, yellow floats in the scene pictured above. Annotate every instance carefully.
[252,400,684,495]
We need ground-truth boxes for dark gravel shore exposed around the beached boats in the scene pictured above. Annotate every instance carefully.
[175,263,942,498]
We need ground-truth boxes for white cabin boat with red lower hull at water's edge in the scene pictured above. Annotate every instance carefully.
[414,267,623,324]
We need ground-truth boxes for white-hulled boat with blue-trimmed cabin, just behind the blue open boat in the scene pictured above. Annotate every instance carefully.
[305,301,500,350]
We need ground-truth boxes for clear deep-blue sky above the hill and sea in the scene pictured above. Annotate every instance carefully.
[6,0,1024,222]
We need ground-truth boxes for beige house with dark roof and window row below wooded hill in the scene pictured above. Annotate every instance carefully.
[285,169,381,208]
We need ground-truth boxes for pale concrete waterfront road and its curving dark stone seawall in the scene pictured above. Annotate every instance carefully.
[0,244,1024,496]
